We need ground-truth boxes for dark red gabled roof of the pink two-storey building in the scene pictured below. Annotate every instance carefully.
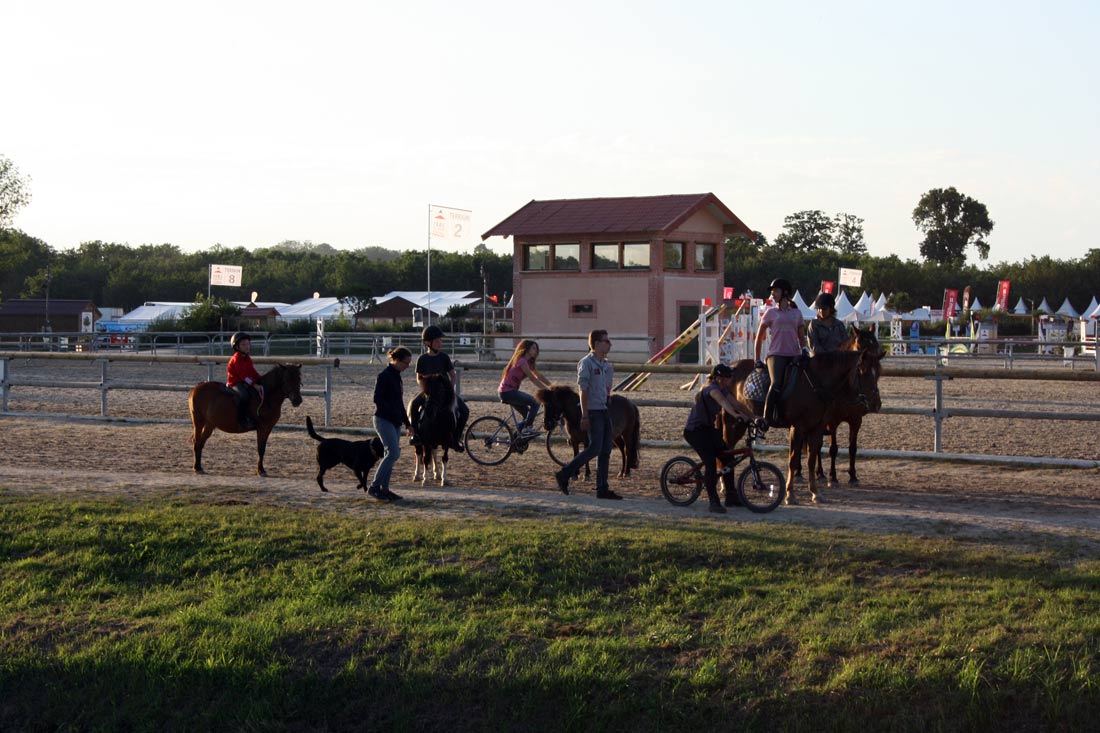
[482,194,756,239]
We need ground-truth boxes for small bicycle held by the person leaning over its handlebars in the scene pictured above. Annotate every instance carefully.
[661,420,784,514]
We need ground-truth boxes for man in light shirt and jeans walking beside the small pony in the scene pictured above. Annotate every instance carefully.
[553,329,623,500]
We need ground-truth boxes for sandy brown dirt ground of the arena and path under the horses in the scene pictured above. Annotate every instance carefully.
[0,360,1100,556]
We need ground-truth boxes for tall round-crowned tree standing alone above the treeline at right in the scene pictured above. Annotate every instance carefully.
[913,186,993,266]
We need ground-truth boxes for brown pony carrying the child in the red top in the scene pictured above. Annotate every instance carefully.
[187,364,301,475]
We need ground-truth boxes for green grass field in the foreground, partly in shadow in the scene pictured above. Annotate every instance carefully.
[0,490,1100,731]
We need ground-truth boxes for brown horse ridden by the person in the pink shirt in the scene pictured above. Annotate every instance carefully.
[726,351,878,504]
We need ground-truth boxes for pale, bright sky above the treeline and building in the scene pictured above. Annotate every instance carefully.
[0,0,1100,263]
